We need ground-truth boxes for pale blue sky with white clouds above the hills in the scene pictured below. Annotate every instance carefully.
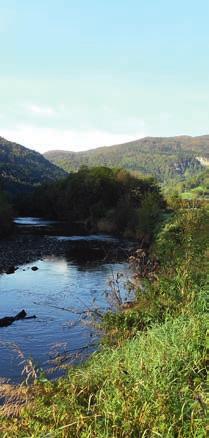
[0,0,209,152]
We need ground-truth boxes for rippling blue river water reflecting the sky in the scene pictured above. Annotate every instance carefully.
[0,218,130,382]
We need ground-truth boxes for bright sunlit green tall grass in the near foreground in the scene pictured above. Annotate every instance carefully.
[0,314,207,438]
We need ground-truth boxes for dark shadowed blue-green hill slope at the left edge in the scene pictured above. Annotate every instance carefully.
[0,137,66,193]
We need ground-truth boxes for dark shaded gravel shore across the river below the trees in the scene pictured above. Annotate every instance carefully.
[0,234,136,273]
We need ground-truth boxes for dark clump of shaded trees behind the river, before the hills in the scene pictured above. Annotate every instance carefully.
[19,167,164,239]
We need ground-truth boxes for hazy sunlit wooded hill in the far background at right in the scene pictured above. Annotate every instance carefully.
[44,135,209,183]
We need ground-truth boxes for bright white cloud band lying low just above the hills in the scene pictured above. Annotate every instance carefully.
[0,125,145,153]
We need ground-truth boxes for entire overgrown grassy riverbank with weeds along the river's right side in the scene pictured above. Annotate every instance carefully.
[0,204,209,438]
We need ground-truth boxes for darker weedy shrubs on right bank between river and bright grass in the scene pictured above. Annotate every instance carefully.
[101,208,209,343]
